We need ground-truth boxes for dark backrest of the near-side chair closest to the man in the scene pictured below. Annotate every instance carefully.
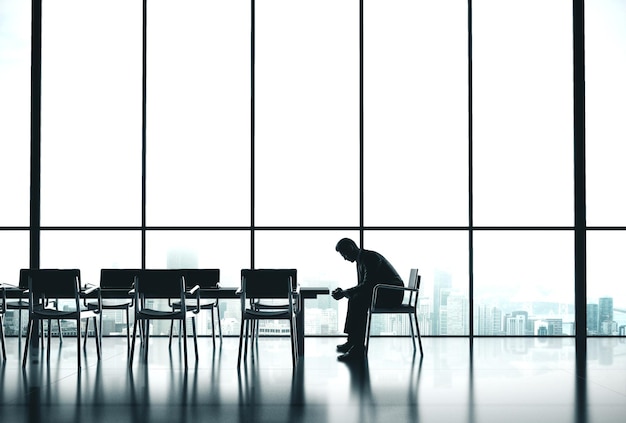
[241,269,296,298]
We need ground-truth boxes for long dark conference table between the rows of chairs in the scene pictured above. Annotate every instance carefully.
[95,286,330,355]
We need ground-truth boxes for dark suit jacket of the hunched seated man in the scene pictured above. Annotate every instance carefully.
[346,250,404,298]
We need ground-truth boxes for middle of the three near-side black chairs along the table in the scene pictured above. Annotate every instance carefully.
[129,269,200,368]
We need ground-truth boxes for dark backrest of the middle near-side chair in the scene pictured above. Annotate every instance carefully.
[135,269,185,298]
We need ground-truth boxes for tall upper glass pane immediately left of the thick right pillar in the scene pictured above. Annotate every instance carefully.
[472,0,574,226]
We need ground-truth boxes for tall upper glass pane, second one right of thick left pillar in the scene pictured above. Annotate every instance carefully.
[146,0,250,226]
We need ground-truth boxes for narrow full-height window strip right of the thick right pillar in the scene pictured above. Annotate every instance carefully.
[585,0,626,336]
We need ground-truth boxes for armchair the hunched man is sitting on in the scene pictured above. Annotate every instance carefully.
[365,269,424,356]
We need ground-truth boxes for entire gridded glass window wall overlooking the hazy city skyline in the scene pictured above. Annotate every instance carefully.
[0,0,626,336]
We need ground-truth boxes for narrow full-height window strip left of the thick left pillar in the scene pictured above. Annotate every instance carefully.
[0,0,31,335]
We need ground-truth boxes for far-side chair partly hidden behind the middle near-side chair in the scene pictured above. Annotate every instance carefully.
[170,269,222,347]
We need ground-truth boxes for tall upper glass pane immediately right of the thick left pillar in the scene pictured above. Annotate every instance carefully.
[41,0,142,226]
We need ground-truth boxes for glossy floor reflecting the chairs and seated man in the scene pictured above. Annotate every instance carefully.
[0,338,626,423]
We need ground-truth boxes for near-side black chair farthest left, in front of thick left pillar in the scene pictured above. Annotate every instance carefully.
[22,269,101,369]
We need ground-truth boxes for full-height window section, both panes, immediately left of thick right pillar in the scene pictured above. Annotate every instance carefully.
[472,0,574,335]
